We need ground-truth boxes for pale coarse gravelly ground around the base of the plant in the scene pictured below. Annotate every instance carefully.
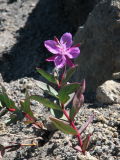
[0,78,120,160]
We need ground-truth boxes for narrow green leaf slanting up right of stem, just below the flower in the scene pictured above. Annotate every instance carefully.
[62,65,78,85]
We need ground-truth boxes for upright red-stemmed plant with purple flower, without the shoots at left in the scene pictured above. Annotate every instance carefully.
[33,33,94,154]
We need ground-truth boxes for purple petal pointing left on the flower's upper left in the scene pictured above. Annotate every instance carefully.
[44,40,59,54]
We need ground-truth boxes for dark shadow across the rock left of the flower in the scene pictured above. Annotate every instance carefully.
[0,0,75,82]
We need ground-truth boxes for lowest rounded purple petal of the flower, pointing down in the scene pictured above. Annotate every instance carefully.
[54,55,66,68]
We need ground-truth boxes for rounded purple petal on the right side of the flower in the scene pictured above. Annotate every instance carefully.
[66,47,80,59]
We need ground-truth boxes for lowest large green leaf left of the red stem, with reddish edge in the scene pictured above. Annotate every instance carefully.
[50,117,77,135]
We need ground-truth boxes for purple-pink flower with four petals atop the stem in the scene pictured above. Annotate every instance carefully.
[44,33,80,68]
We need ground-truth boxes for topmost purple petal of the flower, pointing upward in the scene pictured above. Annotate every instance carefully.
[60,33,72,48]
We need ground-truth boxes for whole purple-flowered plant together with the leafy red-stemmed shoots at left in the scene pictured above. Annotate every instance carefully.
[0,33,94,158]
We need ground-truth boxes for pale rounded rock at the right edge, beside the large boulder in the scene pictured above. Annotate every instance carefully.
[96,80,120,104]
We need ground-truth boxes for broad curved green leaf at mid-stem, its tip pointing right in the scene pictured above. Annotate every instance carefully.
[58,83,80,104]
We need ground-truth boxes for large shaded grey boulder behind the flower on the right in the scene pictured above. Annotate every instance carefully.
[74,0,120,92]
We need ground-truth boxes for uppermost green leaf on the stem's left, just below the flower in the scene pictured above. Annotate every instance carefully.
[37,68,56,84]
